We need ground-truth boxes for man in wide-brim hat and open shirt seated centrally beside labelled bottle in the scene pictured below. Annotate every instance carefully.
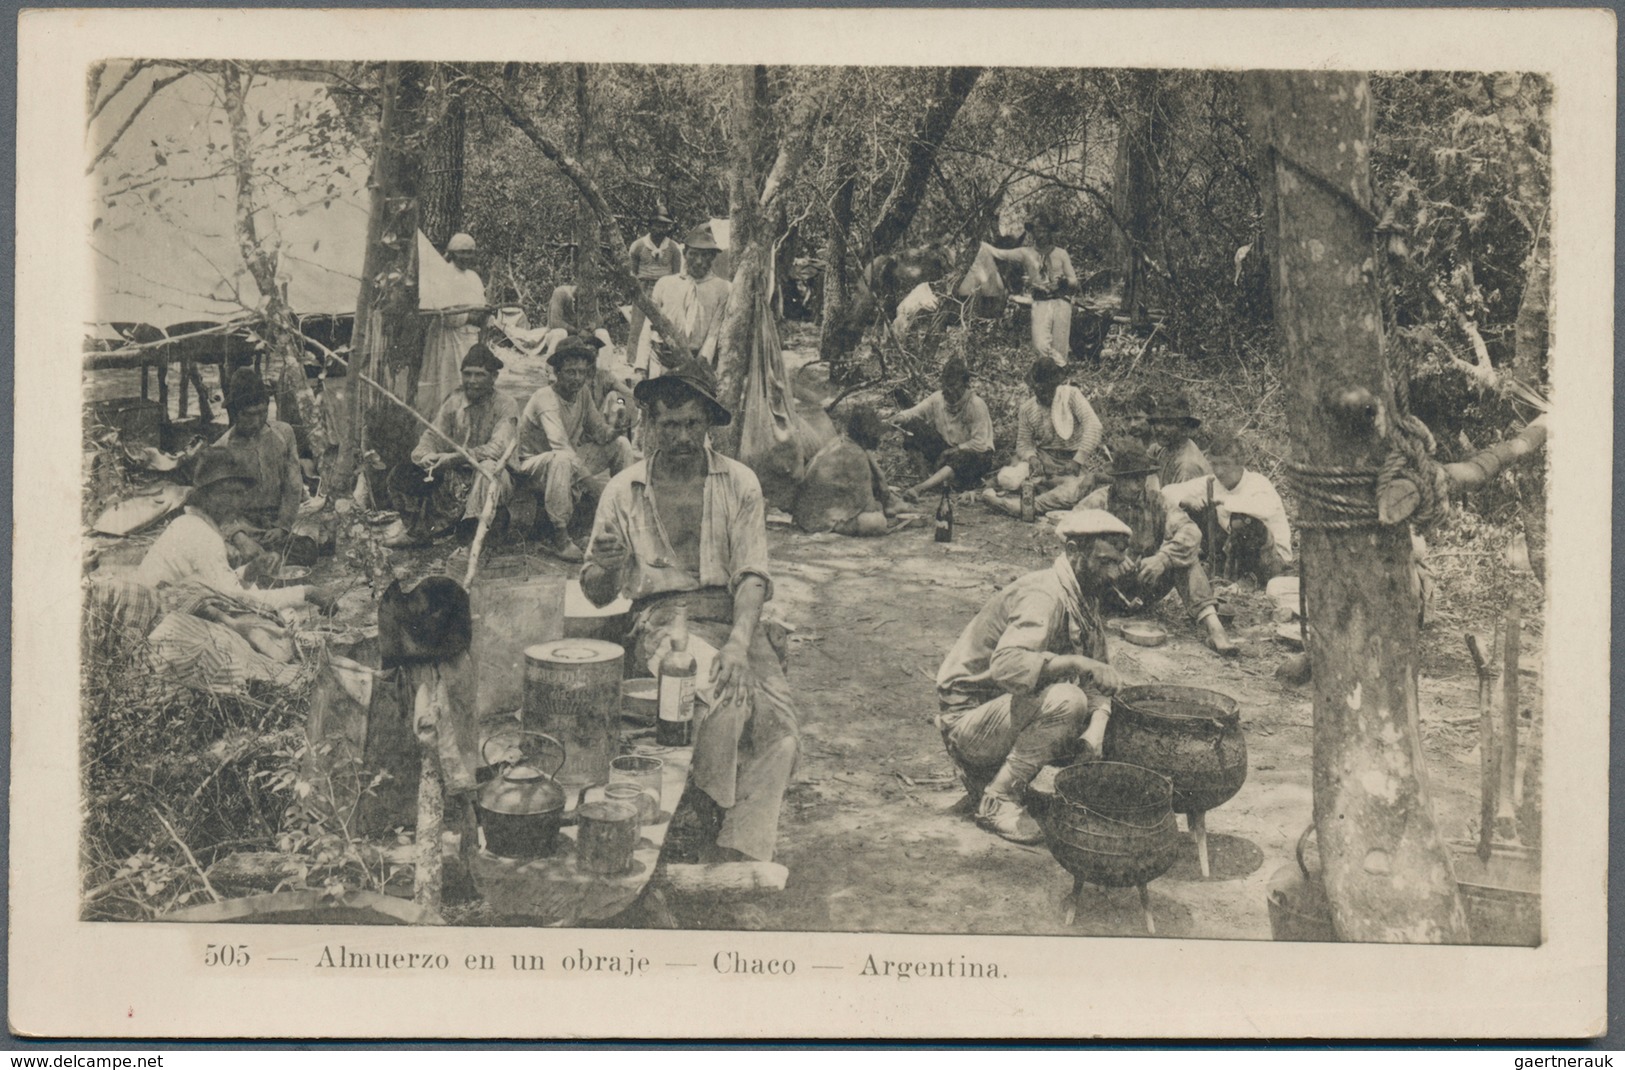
[582,361,800,862]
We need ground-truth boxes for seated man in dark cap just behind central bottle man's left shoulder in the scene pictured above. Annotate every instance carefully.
[514,337,634,561]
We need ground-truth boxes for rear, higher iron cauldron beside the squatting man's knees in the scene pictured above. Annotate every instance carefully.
[1105,683,1246,876]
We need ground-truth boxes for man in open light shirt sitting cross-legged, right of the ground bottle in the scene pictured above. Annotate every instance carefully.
[982,356,1105,517]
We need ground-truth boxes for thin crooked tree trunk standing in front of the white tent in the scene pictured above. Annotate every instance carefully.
[221,60,336,465]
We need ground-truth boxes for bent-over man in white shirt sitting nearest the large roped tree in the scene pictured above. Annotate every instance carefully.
[1162,434,1292,587]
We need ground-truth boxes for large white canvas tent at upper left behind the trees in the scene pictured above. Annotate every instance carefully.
[86,62,464,328]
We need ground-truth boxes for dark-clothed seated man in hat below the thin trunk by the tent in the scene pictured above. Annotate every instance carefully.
[215,368,317,566]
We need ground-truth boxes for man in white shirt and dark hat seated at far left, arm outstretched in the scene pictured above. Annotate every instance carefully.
[135,447,335,610]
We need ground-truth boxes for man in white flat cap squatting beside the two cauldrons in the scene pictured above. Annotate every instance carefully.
[936,509,1131,844]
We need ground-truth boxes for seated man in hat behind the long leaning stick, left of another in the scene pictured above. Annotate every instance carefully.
[384,341,518,546]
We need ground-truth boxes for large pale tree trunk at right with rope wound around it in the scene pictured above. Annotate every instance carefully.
[1245,72,1467,943]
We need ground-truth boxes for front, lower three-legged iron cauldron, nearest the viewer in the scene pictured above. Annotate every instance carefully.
[1040,761,1180,933]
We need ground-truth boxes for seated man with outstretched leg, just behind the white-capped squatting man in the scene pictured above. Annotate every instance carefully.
[1077,441,1238,657]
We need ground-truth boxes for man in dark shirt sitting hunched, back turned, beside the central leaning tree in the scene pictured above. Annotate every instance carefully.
[791,405,897,535]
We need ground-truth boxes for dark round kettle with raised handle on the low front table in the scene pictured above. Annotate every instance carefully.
[475,730,587,859]
